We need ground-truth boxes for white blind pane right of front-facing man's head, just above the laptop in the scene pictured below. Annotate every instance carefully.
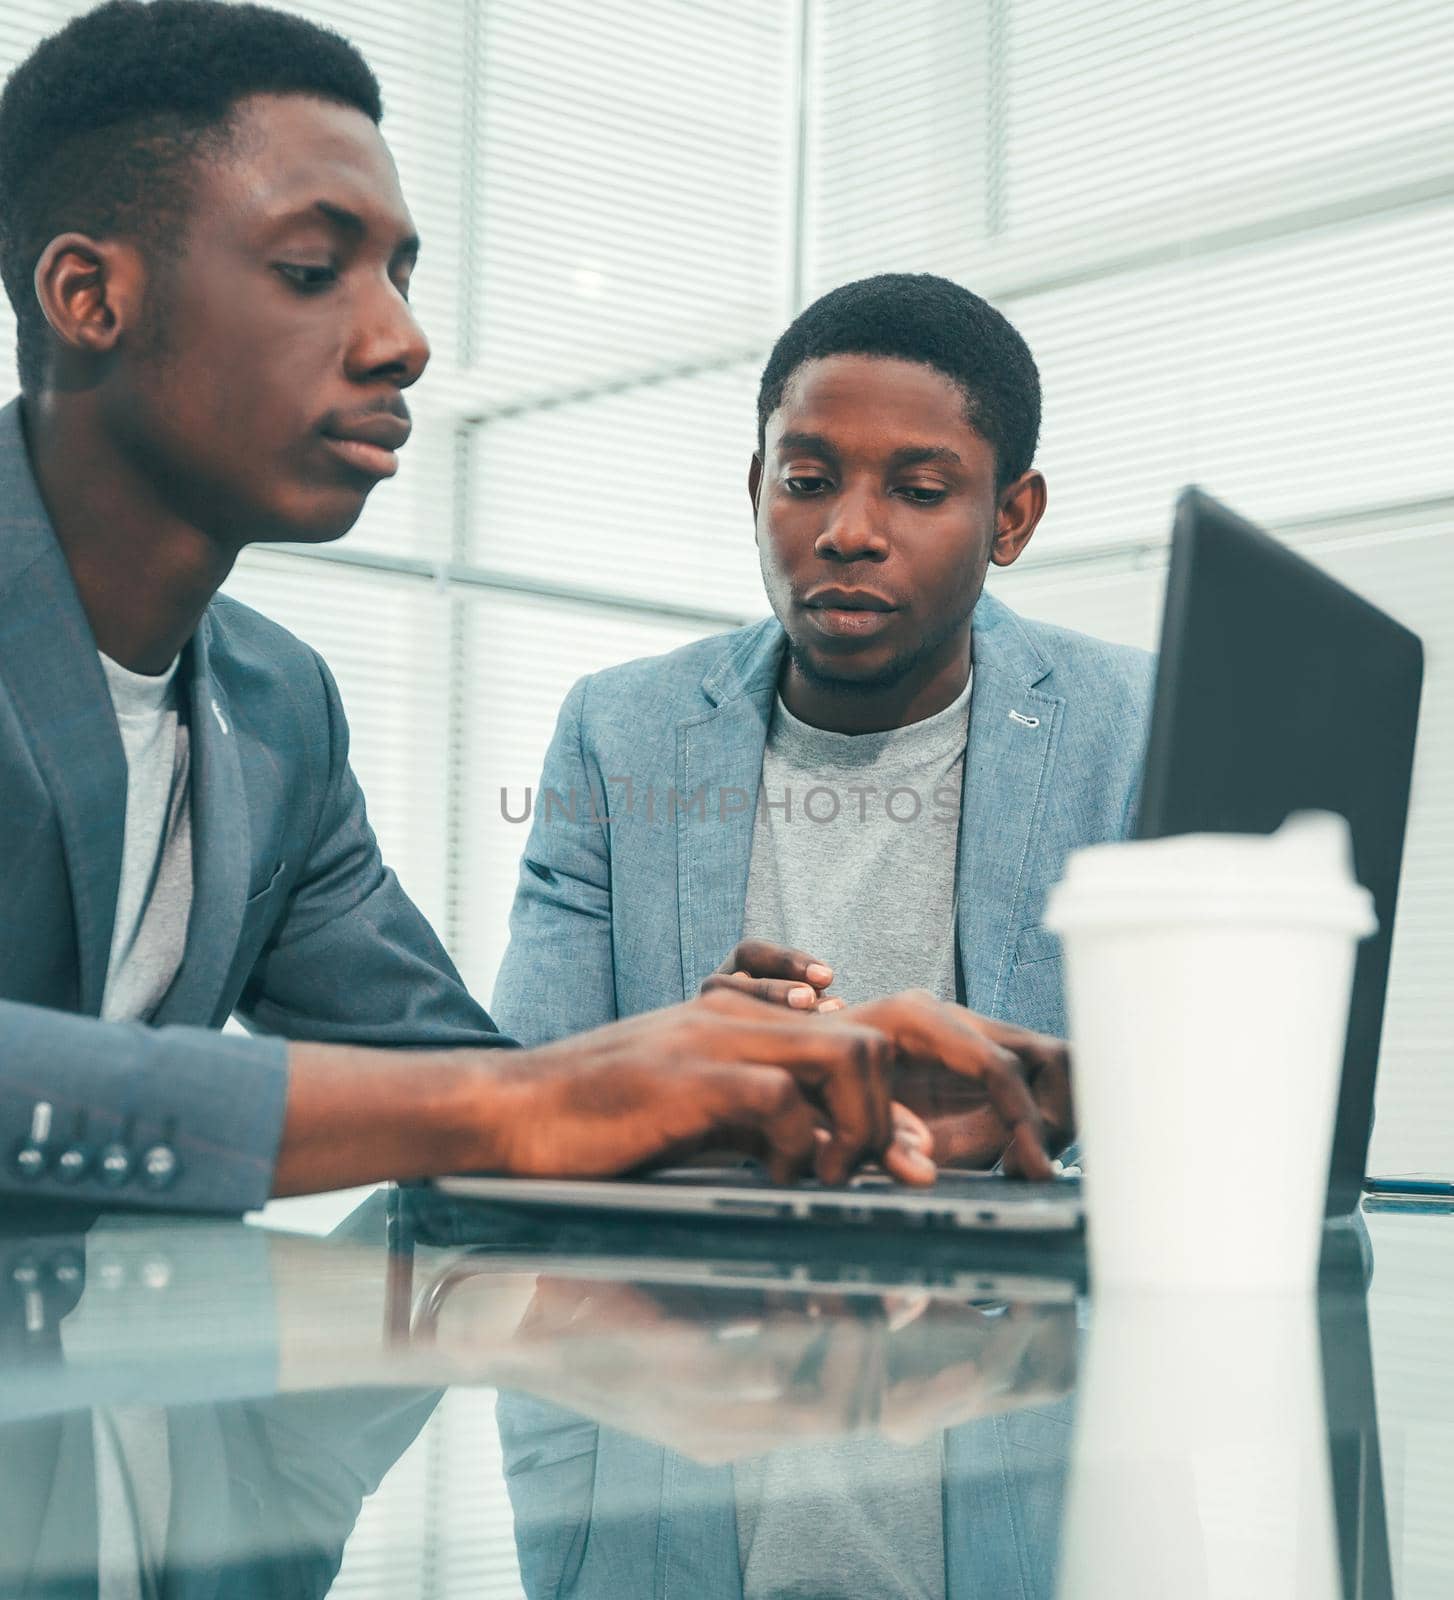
[1000,203,1454,562]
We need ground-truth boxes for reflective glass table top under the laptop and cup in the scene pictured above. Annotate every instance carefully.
[0,1190,1454,1600]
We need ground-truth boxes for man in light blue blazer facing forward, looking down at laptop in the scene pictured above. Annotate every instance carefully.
[494,275,1152,1165]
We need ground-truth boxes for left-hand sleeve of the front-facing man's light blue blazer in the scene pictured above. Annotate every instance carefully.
[493,678,616,1045]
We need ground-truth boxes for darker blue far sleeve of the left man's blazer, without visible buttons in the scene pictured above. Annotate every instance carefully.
[237,658,513,1048]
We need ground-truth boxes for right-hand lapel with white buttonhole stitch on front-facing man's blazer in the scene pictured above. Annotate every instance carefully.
[957,595,1065,1016]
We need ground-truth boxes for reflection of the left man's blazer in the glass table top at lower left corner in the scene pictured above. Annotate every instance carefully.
[0,1208,433,1600]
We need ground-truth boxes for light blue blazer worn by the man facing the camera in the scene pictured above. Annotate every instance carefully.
[493,595,1152,1045]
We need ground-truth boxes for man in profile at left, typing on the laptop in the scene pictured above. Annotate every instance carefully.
[0,0,1055,1210]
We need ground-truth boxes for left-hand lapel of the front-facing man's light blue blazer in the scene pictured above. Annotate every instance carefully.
[669,621,784,998]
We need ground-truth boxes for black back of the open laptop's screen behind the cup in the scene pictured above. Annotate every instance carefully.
[1137,488,1424,1214]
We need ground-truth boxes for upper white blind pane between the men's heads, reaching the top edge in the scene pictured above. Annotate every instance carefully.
[469,0,792,419]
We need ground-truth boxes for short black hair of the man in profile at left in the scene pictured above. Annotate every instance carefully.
[0,0,384,389]
